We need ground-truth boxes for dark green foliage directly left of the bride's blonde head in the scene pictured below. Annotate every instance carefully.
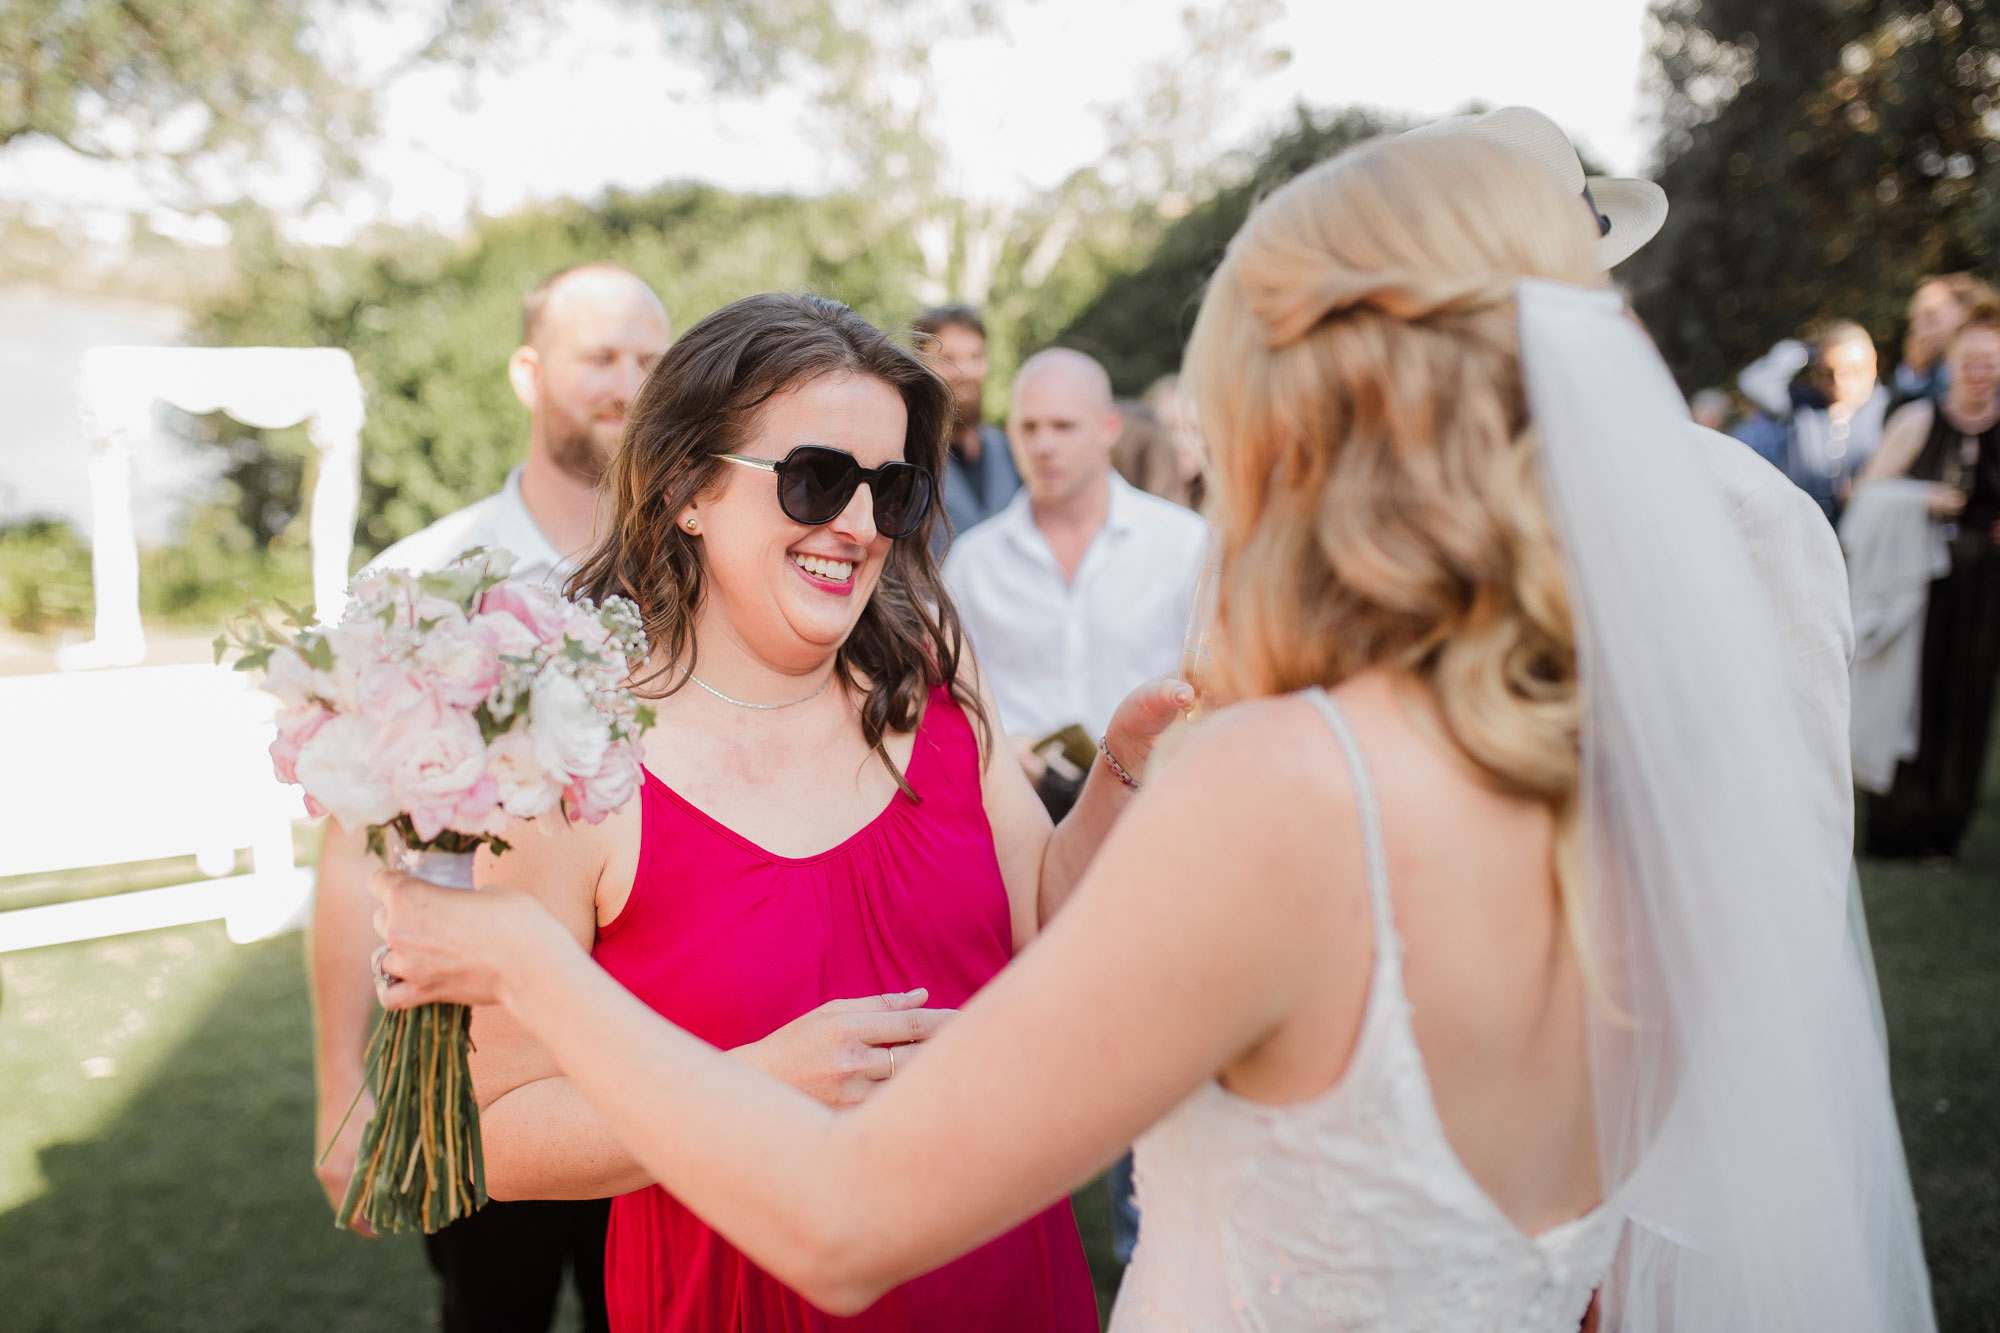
[1038,108,1406,394]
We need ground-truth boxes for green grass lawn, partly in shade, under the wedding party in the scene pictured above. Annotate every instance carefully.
[0,775,2000,1333]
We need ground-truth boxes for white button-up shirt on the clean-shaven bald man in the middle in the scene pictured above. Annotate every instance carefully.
[944,474,1208,739]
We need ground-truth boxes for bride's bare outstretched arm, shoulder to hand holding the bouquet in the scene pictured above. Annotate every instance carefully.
[376,701,1368,1311]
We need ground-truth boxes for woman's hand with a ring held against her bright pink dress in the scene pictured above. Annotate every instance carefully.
[732,987,958,1111]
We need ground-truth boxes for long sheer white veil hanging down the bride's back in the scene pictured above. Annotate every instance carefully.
[1518,280,1934,1333]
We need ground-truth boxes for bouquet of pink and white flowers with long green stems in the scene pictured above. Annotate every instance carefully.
[216,548,652,1231]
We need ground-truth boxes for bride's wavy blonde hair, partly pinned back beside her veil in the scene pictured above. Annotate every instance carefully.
[1188,136,1604,944]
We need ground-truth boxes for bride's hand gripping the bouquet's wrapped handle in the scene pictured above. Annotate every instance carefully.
[368,871,576,1009]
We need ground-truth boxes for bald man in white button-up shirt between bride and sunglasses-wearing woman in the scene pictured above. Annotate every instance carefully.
[944,348,1208,801]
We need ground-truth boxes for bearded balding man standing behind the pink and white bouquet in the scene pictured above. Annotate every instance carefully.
[310,264,670,1333]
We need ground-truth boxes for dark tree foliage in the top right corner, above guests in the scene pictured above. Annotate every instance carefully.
[1620,0,2000,390]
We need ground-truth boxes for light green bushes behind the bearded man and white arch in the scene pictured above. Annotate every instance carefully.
[196,186,936,552]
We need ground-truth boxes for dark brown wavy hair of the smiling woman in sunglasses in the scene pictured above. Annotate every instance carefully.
[570,292,992,793]
